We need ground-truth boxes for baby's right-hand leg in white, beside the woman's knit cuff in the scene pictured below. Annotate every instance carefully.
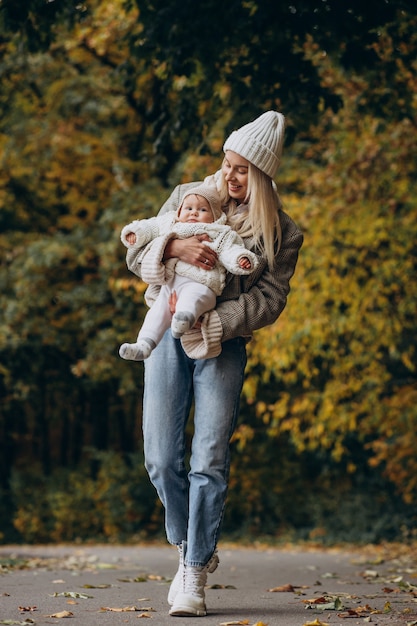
[171,276,216,339]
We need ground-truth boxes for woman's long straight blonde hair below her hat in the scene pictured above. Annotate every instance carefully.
[216,158,282,269]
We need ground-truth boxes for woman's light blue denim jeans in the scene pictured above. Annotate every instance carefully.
[143,330,246,567]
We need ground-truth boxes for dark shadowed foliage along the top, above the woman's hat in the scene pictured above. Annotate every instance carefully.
[128,0,415,141]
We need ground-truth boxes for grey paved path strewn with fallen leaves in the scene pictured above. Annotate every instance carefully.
[0,545,417,626]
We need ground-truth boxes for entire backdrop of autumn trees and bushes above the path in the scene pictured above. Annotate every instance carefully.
[0,0,417,541]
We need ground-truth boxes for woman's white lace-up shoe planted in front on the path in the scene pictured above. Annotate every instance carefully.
[169,552,219,617]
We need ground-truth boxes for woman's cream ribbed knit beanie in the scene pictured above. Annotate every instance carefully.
[223,111,285,178]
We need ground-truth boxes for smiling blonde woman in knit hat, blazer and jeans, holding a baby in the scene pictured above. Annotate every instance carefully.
[123,111,303,616]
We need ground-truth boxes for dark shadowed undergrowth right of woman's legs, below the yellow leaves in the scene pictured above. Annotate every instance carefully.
[223,424,416,544]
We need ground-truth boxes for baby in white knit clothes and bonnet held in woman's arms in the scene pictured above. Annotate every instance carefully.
[119,183,258,361]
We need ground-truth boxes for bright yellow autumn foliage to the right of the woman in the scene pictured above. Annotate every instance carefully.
[247,18,417,503]
